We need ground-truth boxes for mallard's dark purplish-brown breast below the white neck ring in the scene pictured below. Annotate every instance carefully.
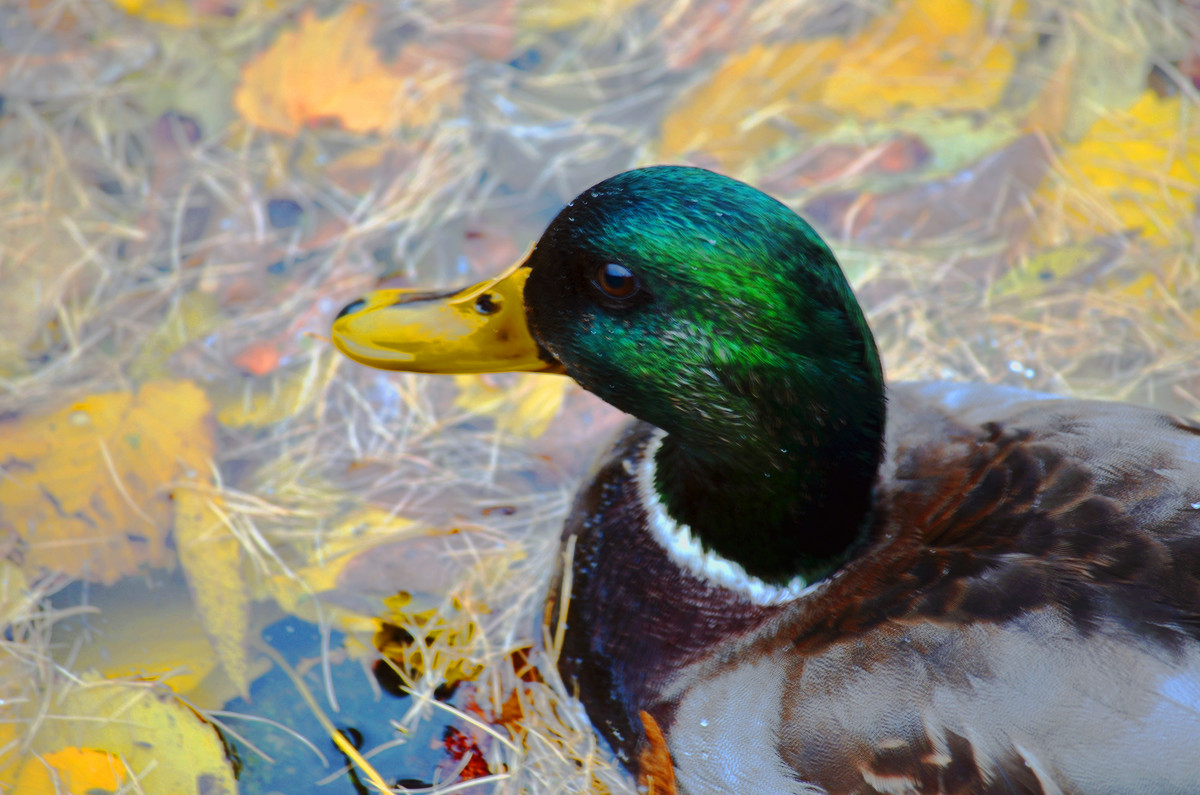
[546,422,787,764]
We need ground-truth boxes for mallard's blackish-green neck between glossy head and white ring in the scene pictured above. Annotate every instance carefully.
[654,333,886,585]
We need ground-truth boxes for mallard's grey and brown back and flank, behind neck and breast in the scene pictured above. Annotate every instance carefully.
[662,383,1200,793]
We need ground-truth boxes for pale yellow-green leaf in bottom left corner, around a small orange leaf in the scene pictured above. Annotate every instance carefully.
[32,677,238,795]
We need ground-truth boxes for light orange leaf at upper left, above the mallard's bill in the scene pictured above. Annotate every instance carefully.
[234,5,462,136]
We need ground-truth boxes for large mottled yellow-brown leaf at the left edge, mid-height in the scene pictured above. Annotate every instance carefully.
[0,381,212,585]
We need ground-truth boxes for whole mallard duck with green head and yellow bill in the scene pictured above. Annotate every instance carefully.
[334,167,1200,795]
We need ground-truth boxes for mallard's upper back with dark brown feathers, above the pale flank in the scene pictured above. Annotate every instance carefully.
[809,383,1200,644]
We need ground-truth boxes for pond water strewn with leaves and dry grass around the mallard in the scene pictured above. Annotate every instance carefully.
[0,0,1200,793]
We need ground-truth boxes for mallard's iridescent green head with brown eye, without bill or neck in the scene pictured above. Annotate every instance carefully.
[524,167,880,455]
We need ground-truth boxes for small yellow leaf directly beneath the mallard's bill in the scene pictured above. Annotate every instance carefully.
[455,375,570,438]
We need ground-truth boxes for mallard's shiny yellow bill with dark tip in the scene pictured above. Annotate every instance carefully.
[332,262,563,373]
